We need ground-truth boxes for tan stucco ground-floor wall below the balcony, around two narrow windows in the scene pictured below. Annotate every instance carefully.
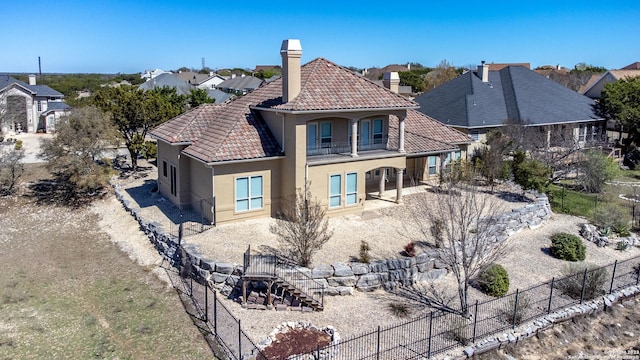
[308,156,406,216]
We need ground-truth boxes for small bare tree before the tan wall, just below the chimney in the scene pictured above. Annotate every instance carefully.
[270,184,333,266]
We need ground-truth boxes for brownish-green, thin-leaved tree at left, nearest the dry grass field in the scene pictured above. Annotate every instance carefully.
[39,106,119,195]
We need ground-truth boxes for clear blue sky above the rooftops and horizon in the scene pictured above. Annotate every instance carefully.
[0,0,640,73]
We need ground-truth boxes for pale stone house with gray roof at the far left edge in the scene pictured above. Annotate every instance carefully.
[0,75,71,133]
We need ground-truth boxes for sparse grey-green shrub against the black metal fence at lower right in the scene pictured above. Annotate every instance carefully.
[556,263,609,300]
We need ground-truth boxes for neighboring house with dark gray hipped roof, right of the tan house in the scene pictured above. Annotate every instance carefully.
[415,63,606,151]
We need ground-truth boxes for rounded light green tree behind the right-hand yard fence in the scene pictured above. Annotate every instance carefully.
[578,149,619,193]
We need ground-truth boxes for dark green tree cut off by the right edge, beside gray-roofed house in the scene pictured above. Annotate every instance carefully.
[596,77,640,145]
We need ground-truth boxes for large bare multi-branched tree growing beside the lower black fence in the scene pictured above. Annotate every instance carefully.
[407,182,505,316]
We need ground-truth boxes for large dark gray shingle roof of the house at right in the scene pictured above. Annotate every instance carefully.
[415,66,600,128]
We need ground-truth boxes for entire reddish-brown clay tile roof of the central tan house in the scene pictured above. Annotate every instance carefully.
[150,59,456,163]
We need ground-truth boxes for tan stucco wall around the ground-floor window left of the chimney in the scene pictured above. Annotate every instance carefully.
[213,159,282,223]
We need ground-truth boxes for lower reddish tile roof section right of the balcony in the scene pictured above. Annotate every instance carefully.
[389,110,471,155]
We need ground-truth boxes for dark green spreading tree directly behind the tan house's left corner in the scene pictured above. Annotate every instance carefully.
[93,86,186,171]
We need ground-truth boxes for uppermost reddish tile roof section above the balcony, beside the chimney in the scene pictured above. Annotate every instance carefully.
[260,58,418,112]
